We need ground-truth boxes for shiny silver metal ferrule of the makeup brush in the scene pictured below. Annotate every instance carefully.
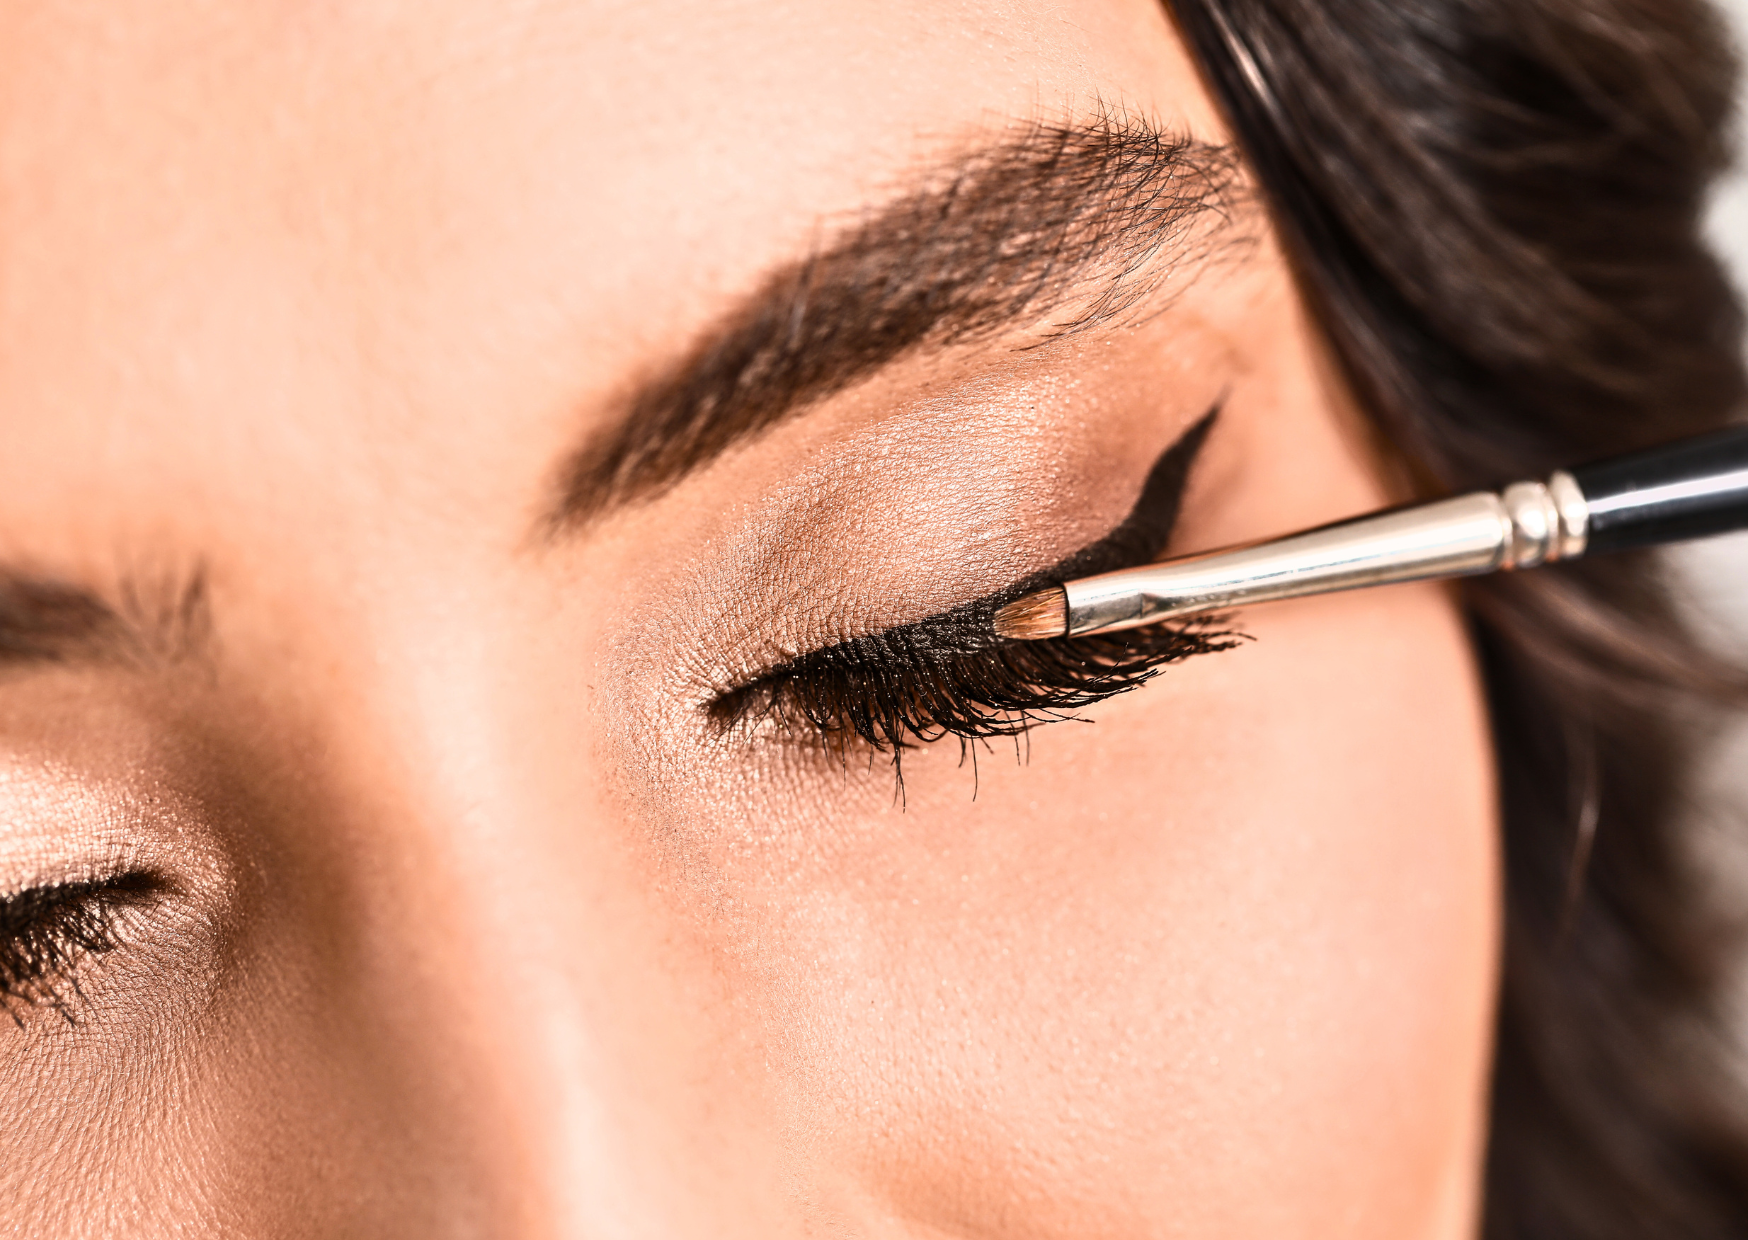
[1063,472,1589,635]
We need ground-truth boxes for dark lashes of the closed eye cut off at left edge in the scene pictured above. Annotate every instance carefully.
[0,873,163,1028]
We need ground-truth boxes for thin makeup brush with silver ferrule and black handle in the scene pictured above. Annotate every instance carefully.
[995,427,1748,640]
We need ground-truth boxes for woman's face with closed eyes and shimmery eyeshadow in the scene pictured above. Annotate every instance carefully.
[0,0,1496,1240]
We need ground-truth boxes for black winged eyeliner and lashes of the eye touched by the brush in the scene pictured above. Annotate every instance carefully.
[706,409,1241,764]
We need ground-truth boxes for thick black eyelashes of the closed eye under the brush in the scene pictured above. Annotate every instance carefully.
[708,603,1245,764]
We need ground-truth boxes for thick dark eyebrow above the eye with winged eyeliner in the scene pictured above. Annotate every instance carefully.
[549,114,1245,532]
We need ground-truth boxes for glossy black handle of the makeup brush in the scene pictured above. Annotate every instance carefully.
[1568,427,1748,554]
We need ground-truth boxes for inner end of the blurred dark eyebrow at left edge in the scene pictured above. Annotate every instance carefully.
[0,567,212,670]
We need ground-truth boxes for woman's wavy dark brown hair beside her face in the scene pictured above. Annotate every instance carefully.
[1173,0,1748,1240]
